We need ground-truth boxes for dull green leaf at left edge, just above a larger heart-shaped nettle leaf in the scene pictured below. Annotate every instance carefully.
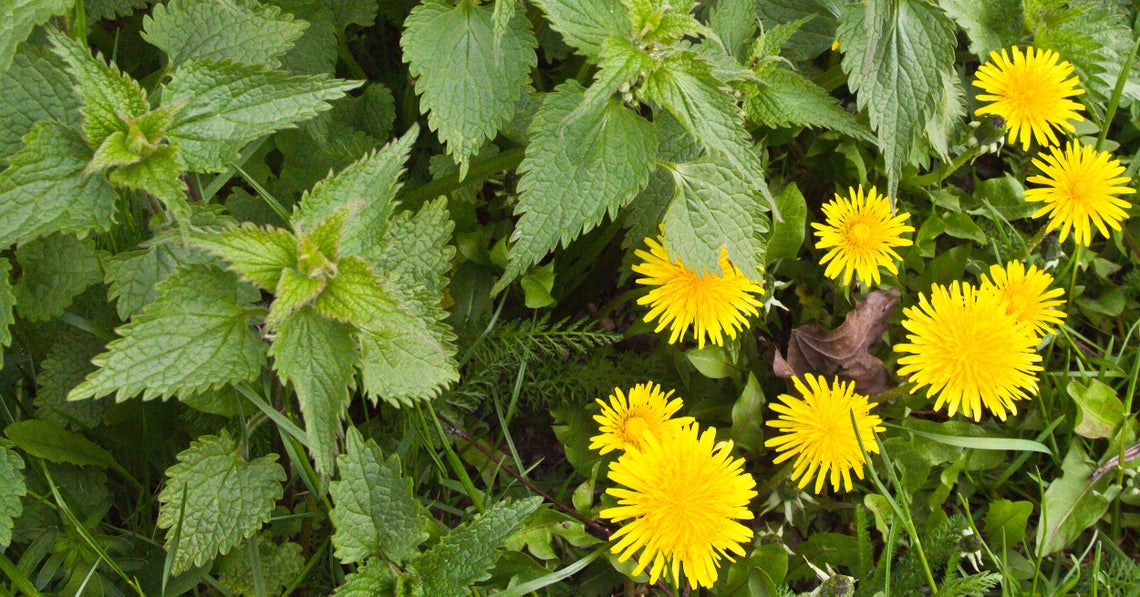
[0,43,82,160]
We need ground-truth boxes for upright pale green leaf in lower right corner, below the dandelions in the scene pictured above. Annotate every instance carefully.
[1036,442,1109,557]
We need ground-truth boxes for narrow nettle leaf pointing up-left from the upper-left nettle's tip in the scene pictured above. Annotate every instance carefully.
[48,30,150,147]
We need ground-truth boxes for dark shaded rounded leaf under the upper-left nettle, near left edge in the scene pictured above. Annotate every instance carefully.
[13,235,103,321]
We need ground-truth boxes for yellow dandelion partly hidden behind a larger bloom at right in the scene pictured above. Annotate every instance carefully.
[982,261,1065,338]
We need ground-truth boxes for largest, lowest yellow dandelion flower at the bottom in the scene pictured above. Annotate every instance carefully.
[601,425,756,588]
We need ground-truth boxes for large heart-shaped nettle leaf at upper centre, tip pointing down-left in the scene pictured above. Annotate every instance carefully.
[494,82,658,292]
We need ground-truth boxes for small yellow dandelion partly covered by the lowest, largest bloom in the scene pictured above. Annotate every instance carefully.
[589,382,693,453]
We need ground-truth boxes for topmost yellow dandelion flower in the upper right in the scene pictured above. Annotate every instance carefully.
[974,46,1084,150]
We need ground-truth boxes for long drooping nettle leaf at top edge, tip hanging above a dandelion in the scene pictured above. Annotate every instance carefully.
[836,0,956,197]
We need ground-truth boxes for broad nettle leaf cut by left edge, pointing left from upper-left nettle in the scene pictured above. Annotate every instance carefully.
[0,122,115,246]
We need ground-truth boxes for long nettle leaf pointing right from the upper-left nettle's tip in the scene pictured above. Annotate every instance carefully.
[162,60,360,172]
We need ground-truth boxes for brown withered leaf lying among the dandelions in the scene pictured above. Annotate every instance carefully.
[772,288,899,395]
